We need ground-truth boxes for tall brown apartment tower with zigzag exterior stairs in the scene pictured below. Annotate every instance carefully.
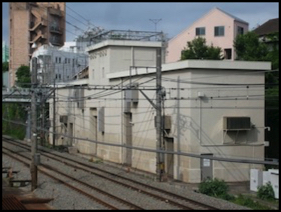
[9,2,65,86]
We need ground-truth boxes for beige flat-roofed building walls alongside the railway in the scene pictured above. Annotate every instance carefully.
[50,41,270,183]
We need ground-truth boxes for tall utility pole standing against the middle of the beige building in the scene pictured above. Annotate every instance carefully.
[156,48,165,182]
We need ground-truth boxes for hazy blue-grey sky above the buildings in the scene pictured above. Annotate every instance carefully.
[2,2,279,42]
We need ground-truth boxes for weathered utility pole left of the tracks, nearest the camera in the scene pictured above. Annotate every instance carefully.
[30,58,37,191]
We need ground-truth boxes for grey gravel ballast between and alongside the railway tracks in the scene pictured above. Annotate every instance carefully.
[2,138,249,210]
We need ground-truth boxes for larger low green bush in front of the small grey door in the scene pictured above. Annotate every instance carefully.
[199,178,234,200]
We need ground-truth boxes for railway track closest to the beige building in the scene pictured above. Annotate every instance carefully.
[2,139,218,210]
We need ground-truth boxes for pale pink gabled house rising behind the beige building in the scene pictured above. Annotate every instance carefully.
[166,8,249,63]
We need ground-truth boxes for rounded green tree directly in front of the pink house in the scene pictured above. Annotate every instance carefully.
[181,37,222,60]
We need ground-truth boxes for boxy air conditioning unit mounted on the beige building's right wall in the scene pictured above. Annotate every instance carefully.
[223,117,251,131]
